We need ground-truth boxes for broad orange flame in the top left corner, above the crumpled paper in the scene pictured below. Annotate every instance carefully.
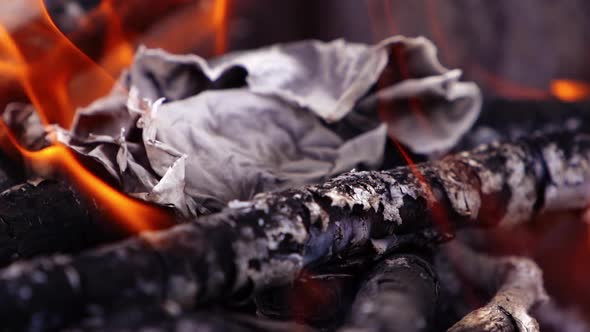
[0,0,114,128]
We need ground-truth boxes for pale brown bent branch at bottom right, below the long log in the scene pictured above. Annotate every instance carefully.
[445,241,548,332]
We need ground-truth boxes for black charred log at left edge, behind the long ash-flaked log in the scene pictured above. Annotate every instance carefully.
[0,181,136,265]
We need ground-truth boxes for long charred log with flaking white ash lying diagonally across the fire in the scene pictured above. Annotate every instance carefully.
[0,134,590,326]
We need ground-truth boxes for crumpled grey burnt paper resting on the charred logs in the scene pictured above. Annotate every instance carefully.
[8,37,481,215]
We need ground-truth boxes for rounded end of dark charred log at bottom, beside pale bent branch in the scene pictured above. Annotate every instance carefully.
[340,254,438,332]
